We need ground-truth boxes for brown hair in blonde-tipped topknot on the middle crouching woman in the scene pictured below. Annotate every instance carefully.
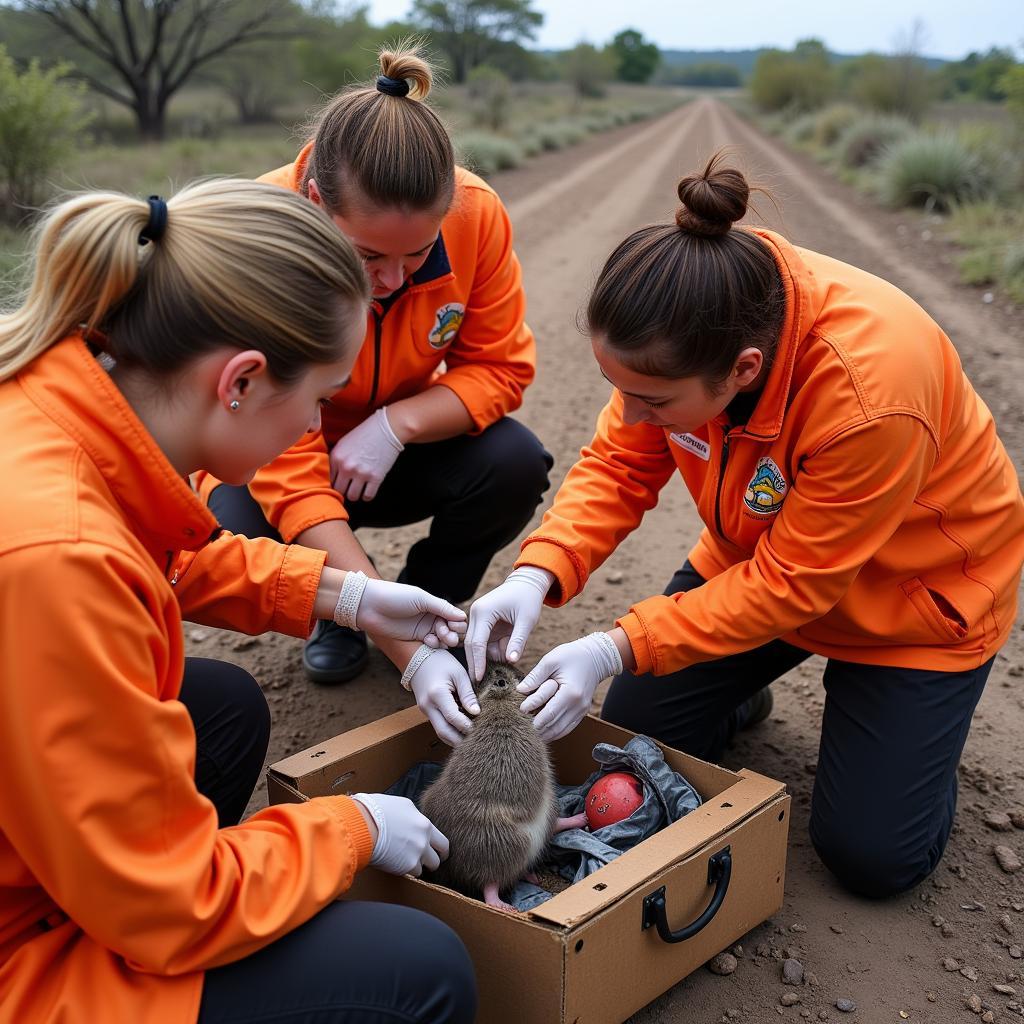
[303,40,455,215]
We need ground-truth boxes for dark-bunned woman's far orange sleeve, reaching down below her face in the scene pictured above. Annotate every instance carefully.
[515,391,676,606]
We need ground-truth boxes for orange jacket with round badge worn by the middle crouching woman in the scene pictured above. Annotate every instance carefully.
[197,142,537,541]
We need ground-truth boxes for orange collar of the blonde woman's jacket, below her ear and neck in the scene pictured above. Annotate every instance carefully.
[18,336,219,552]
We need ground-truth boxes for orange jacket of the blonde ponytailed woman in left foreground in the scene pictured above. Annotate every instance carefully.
[0,338,371,1024]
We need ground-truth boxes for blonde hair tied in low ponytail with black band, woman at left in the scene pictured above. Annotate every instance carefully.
[0,179,370,383]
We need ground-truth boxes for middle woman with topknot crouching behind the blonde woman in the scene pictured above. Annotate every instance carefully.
[201,49,551,716]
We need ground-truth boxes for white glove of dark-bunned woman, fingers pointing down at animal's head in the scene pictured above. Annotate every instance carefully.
[466,565,555,681]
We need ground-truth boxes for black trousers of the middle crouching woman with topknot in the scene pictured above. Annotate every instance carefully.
[210,417,553,603]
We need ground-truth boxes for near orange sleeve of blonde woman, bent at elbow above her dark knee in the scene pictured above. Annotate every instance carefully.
[0,542,371,975]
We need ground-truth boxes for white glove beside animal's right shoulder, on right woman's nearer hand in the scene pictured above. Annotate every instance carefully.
[516,633,623,743]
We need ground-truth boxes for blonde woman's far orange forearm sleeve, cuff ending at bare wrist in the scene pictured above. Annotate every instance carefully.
[171,532,327,638]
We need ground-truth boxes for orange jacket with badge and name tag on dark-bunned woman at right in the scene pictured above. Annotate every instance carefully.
[516,230,1024,675]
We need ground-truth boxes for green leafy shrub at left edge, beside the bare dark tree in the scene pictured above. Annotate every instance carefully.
[0,45,89,221]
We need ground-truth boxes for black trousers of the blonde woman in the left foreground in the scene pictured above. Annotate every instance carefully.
[181,658,476,1024]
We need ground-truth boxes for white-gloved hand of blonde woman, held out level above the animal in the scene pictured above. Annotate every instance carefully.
[334,572,466,647]
